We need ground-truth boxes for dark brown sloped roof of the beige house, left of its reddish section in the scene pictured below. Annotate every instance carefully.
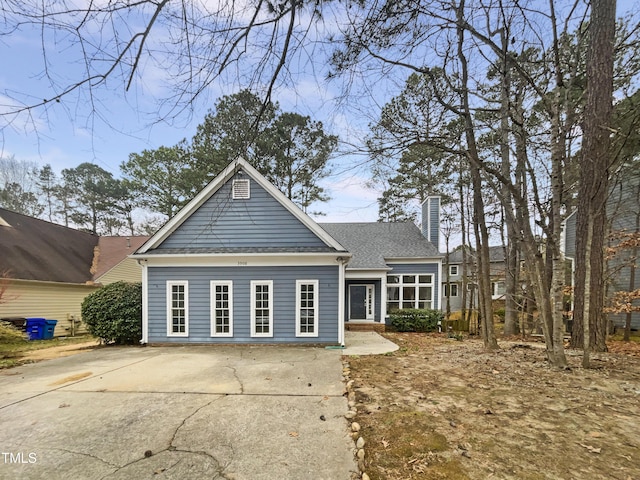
[0,208,98,284]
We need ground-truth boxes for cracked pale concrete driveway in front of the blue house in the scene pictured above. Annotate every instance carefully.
[0,346,357,480]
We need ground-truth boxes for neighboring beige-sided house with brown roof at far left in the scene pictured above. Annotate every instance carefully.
[0,208,147,336]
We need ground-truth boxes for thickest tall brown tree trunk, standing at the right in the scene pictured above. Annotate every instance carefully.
[573,0,616,351]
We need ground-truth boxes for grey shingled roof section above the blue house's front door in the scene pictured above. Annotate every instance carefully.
[320,222,442,269]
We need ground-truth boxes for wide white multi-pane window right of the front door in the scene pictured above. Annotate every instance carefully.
[387,274,433,313]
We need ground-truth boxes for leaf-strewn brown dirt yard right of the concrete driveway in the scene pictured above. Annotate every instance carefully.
[347,333,640,480]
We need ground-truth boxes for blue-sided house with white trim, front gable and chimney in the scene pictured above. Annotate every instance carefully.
[132,159,442,345]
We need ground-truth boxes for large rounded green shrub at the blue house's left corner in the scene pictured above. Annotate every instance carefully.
[82,282,142,345]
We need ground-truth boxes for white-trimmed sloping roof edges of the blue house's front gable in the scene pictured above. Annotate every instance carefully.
[134,158,346,256]
